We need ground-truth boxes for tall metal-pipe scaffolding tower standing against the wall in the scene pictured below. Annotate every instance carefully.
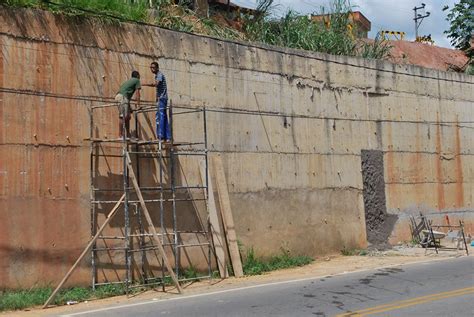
[90,101,212,293]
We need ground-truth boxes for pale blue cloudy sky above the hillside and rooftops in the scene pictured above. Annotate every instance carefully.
[232,0,458,48]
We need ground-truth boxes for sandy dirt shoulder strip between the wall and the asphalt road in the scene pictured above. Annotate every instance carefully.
[0,245,474,317]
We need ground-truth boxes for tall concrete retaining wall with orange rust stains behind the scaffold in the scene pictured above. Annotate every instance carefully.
[0,8,474,287]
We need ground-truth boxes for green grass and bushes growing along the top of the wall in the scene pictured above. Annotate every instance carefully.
[6,0,391,58]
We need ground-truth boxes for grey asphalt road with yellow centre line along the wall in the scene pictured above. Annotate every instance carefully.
[57,257,474,317]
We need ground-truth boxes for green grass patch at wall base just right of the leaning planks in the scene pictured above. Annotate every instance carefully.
[243,248,314,275]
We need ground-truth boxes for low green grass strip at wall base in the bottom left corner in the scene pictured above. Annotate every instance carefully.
[0,285,125,311]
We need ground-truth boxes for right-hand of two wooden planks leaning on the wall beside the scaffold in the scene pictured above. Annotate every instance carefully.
[213,155,244,277]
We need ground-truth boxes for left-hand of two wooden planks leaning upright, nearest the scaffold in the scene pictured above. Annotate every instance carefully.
[199,160,229,278]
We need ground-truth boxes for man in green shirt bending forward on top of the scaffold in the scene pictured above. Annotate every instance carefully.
[115,70,142,138]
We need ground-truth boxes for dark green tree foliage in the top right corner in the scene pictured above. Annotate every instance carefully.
[443,0,474,58]
